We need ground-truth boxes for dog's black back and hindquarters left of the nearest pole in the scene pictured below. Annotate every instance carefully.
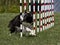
[8,15,22,33]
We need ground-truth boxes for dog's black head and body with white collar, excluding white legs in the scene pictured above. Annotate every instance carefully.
[8,13,33,33]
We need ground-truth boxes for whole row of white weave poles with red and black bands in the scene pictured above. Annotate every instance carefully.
[20,0,54,36]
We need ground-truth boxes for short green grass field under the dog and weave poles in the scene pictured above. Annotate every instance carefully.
[0,13,60,45]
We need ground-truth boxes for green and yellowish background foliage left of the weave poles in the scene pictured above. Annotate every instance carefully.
[0,0,19,12]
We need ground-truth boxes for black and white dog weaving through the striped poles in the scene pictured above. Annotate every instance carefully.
[8,12,36,36]
